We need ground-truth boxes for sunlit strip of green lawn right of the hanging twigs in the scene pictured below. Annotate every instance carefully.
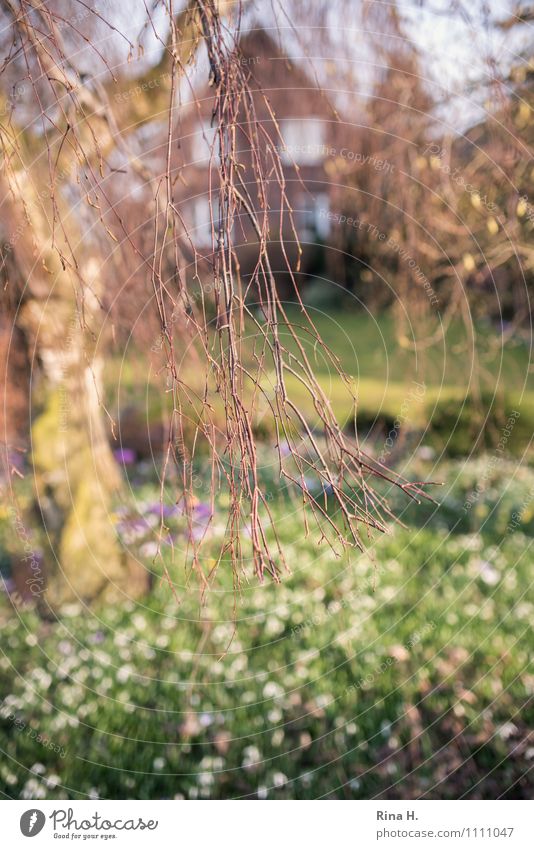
[272,309,534,425]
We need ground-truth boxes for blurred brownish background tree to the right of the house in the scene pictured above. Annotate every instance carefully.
[332,2,534,340]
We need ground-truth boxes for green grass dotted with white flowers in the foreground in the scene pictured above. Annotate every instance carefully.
[0,456,534,799]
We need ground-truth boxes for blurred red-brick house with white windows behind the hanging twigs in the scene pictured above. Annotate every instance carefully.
[173,29,346,294]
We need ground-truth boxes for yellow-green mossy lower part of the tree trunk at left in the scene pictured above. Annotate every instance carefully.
[32,348,148,608]
